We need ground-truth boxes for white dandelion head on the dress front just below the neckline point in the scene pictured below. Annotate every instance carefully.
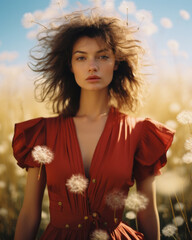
[66,174,89,194]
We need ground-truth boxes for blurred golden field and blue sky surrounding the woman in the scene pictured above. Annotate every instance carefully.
[0,0,192,240]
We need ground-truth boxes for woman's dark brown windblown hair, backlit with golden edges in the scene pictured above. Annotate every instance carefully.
[30,10,144,116]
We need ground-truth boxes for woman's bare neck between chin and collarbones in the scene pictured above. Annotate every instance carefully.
[76,89,109,119]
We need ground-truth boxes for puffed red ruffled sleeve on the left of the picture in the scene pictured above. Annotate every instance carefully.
[12,118,45,169]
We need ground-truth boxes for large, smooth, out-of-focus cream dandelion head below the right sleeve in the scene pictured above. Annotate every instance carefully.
[156,170,188,196]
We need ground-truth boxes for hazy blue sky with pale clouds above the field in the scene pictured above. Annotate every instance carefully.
[0,0,192,81]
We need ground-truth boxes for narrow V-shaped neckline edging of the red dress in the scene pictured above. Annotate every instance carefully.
[71,107,113,178]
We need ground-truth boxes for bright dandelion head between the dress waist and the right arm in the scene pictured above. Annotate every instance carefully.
[125,192,149,212]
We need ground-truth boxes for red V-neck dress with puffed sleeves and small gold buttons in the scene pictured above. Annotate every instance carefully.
[13,107,174,240]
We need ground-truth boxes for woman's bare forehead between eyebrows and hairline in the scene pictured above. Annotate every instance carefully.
[73,36,110,52]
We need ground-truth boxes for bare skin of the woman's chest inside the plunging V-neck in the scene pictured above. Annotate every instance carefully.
[74,117,106,173]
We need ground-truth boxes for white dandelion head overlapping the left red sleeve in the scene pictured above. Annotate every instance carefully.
[32,145,54,164]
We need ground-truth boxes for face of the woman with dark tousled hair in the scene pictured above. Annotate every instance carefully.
[71,36,117,90]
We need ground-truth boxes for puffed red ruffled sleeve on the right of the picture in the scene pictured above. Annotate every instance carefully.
[133,118,175,181]
